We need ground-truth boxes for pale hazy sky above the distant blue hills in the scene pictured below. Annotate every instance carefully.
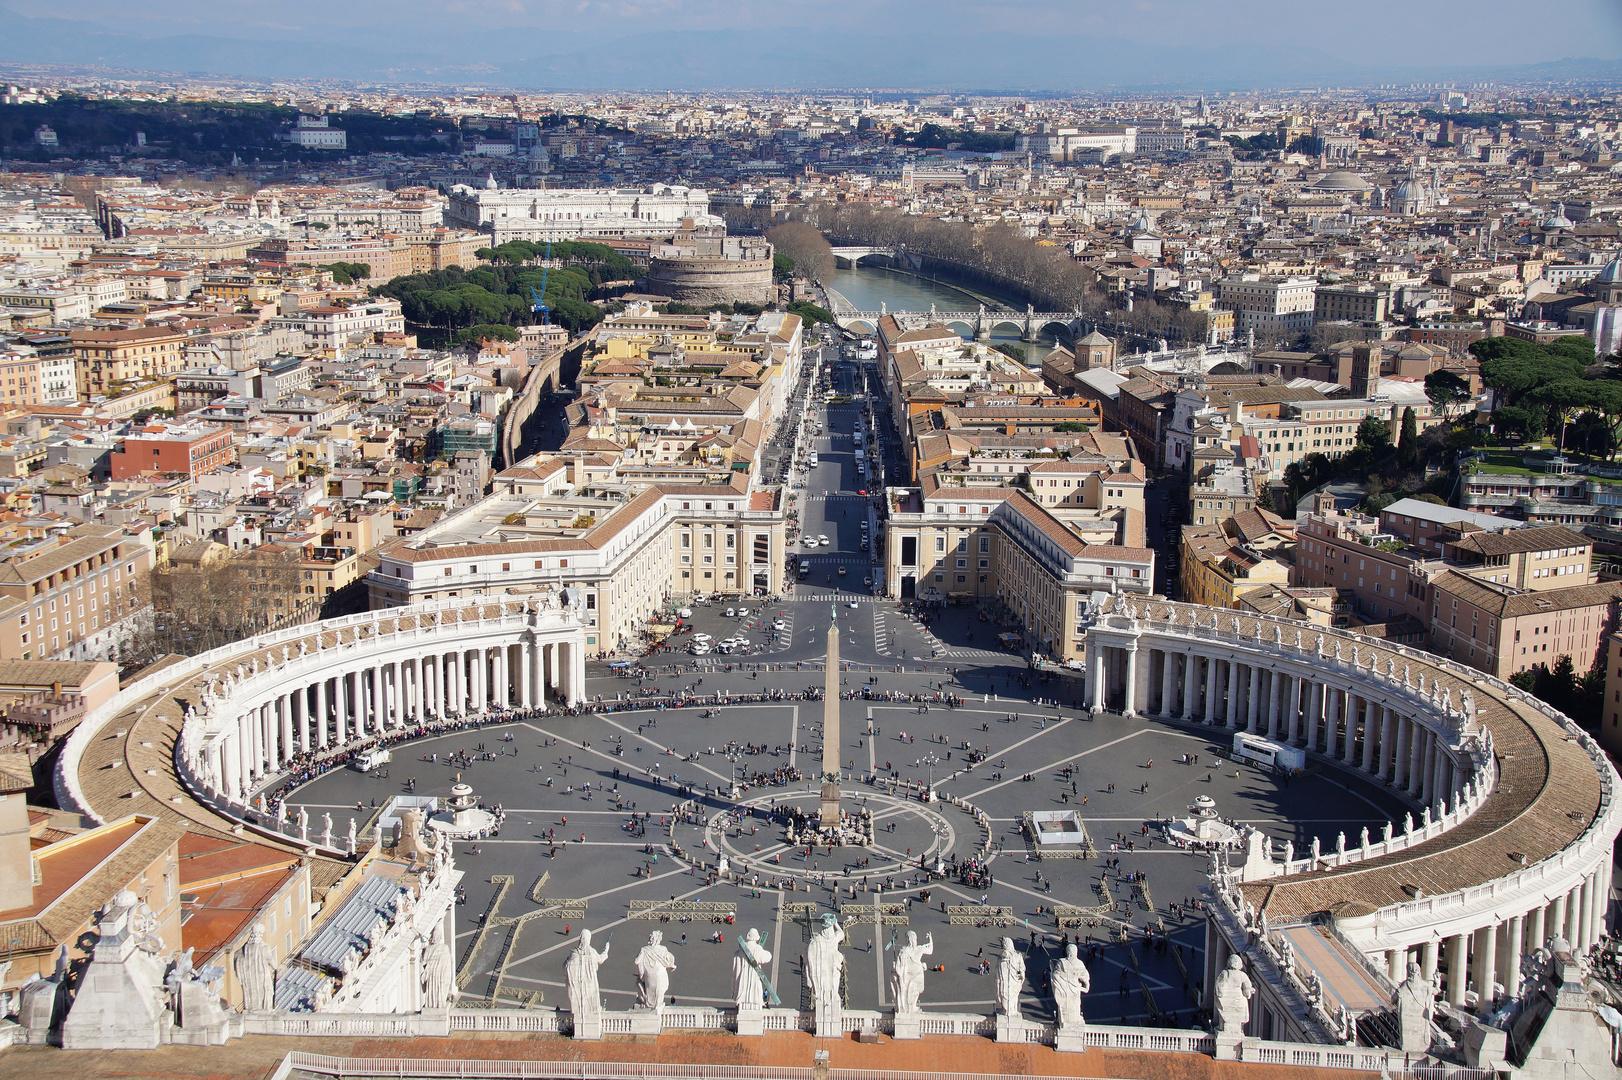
[3,0,1622,66]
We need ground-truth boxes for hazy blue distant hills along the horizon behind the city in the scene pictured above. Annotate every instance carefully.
[0,10,1622,94]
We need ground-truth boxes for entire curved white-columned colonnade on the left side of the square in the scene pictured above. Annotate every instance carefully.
[57,597,586,855]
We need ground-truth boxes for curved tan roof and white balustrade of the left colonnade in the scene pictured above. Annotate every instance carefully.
[55,597,590,862]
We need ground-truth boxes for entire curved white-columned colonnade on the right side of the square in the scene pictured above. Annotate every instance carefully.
[1087,600,1622,1035]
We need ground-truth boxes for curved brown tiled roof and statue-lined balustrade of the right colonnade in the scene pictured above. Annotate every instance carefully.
[1095,600,1622,924]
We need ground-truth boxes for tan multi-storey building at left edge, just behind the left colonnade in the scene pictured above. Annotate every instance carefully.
[0,525,152,660]
